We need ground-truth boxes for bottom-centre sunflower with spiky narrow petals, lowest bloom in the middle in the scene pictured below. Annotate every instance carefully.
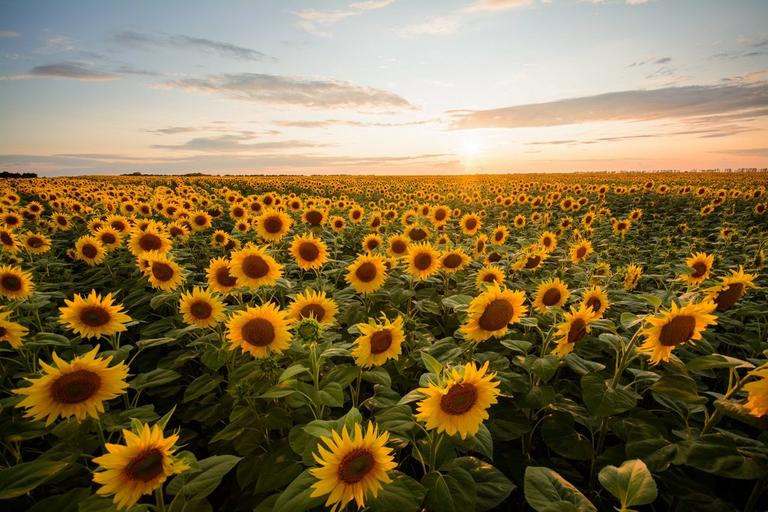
[309,423,397,512]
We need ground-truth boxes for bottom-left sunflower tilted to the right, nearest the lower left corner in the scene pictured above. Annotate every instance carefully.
[93,423,189,510]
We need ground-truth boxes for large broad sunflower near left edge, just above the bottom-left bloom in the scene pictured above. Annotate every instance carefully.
[13,347,128,426]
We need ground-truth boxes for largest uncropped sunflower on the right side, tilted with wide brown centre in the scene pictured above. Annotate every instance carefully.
[637,301,717,364]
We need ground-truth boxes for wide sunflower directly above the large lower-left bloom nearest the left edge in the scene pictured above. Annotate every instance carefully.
[59,290,131,338]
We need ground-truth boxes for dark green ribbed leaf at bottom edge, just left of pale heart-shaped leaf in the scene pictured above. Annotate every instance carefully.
[524,466,597,512]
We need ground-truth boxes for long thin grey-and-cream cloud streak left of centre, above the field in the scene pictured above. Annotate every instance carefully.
[161,73,415,110]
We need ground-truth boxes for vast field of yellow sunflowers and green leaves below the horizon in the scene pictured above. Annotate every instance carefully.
[0,172,768,512]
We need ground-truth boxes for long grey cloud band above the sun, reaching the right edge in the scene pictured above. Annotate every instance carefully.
[450,82,768,129]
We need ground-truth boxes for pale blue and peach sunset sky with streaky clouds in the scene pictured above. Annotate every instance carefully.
[0,0,768,175]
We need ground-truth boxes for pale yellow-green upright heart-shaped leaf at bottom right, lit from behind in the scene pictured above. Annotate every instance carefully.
[598,459,658,511]
